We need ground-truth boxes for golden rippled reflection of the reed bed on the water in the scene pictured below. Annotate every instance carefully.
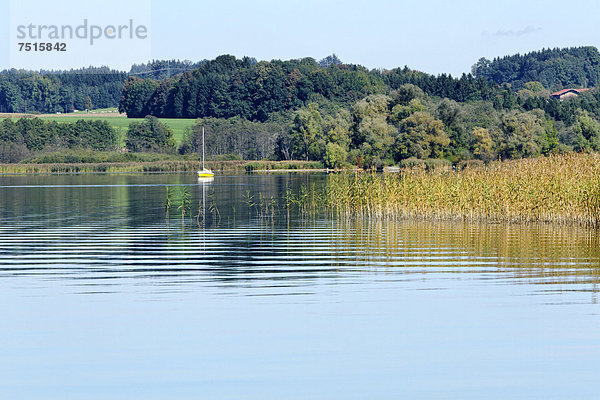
[338,221,600,285]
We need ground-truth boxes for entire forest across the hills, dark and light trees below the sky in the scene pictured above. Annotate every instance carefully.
[0,47,600,168]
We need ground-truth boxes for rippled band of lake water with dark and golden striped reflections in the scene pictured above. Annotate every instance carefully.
[0,211,600,302]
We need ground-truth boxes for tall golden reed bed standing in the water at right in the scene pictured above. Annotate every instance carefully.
[322,154,600,227]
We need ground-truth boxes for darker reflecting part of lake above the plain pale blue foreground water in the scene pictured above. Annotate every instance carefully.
[0,175,600,294]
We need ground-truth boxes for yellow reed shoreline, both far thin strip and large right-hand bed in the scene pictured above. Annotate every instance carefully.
[0,153,600,228]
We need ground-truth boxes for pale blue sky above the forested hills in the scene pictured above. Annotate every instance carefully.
[0,0,600,75]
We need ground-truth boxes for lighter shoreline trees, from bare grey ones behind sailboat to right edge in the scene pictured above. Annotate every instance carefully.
[179,84,600,168]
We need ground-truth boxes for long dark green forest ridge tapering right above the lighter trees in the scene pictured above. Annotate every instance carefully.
[119,56,516,121]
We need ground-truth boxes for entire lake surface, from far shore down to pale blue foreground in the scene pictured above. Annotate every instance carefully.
[0,174,600,400]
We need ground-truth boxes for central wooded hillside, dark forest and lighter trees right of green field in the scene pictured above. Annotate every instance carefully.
[115,51,600,167]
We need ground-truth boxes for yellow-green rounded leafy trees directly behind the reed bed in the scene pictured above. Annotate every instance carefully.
[272,84,564,167]
